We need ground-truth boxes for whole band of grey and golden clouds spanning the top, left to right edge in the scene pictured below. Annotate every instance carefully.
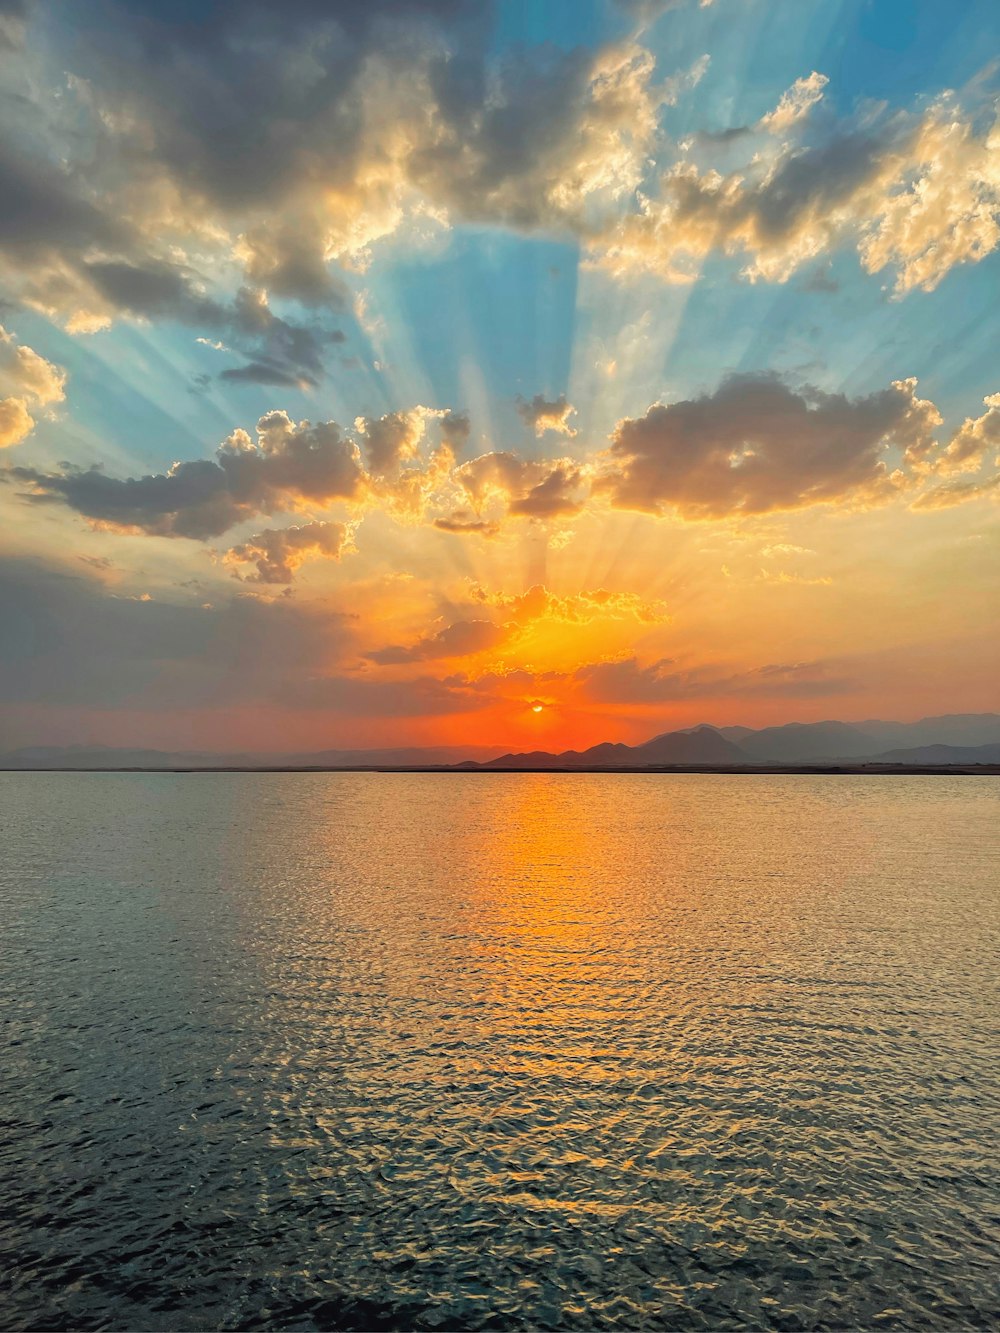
[0,0,1000,370]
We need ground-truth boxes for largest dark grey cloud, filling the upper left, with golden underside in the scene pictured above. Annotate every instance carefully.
[0,0,677,343]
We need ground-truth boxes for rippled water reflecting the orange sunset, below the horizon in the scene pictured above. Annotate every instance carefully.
[0,774,1000,1329]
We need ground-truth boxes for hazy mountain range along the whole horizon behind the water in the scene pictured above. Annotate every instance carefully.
[0,713,1000,770]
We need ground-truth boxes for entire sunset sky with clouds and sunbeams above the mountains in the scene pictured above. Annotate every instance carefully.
[0,0,1000,753]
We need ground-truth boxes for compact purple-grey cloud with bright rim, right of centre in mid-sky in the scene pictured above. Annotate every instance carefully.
[595,376,940,519]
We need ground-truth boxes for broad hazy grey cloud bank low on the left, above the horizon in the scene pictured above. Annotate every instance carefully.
[0,557,501,748]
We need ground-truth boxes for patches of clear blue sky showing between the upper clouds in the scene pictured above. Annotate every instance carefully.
[20,0,1000,468]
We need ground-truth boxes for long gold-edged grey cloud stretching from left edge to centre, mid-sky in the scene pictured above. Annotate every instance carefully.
[0,391,557,549]
